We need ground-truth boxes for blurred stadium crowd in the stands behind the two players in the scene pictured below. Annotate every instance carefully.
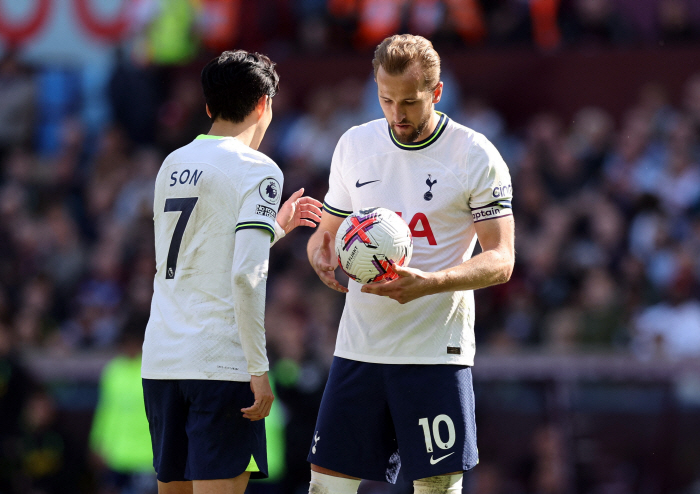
[0,0,700,494]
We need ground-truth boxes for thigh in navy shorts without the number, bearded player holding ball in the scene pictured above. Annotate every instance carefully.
[308,357,398,480]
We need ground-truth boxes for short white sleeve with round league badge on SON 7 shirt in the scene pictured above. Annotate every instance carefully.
[236,163,283,240]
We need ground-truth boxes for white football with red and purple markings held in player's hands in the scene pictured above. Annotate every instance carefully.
[335,208,413,284]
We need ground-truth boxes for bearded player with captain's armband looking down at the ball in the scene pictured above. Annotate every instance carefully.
[308,35,514,494]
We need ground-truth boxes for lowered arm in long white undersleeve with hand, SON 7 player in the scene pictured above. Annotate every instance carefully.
[231,228,274,420]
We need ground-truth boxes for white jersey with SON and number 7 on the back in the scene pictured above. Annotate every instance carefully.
[142,136,282,381]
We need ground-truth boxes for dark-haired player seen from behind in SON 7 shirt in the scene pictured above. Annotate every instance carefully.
[141,50,321,494]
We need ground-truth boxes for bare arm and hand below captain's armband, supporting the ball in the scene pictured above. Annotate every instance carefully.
[362,215,515,304]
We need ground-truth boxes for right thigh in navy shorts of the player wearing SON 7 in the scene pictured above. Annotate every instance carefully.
[182,380,267,480]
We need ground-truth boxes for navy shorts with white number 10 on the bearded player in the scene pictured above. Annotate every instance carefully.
[308,357,478,484]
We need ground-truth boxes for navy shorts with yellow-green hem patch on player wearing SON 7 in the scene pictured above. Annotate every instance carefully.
[143,379,267,482]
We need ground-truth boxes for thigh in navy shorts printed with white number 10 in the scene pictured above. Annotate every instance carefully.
[387,365,478,480]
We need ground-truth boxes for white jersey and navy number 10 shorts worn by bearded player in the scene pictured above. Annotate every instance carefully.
[309,114,512,482]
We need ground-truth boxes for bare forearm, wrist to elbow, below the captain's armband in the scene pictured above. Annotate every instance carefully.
[431,249,514,293]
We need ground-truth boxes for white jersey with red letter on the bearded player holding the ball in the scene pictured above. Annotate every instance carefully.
[324,114,513,365]
